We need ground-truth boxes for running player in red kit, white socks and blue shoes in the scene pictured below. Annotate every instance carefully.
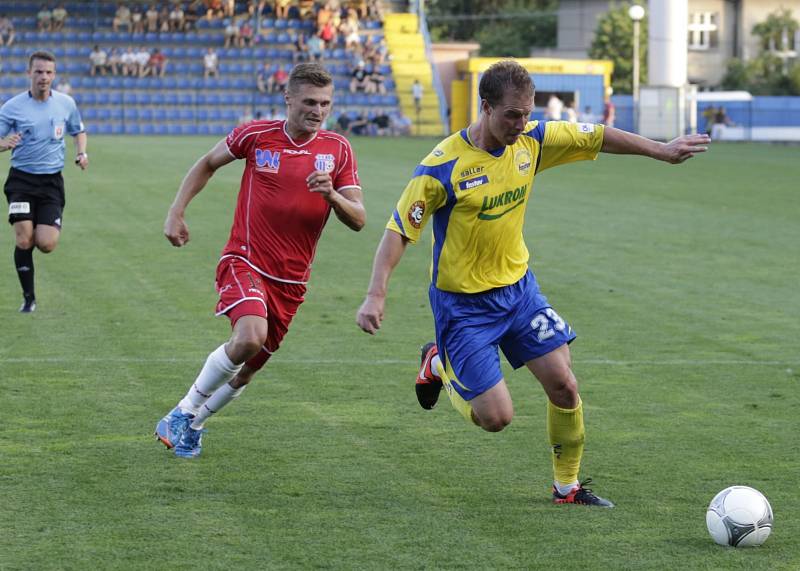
[156,63,366,458]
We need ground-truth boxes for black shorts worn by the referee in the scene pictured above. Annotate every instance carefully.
[3,167,66,228]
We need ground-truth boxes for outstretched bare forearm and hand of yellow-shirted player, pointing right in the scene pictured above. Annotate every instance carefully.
[600,127,711,164]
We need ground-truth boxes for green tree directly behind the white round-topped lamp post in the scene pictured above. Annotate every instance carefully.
[589,2,648,93]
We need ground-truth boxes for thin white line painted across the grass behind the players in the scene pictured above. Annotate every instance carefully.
[0,355,800,367]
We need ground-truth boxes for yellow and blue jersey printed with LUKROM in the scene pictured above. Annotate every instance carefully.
[386,121,603,293]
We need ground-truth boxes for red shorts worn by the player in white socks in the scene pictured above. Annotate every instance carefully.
[215,258,306,369]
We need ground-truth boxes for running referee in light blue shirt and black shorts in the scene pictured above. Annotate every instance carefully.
[0,51,89,313]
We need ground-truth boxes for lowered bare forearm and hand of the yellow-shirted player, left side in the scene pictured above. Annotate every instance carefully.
[356,230,408,335]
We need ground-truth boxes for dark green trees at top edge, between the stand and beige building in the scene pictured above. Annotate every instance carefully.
[426,0,558,57]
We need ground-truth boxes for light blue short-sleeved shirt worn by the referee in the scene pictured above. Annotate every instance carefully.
[0,90,84,174]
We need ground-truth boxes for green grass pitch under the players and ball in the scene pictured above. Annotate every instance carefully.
[0,137,800,571]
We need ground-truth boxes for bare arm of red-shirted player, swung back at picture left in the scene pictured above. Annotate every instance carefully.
[164,139,235,248]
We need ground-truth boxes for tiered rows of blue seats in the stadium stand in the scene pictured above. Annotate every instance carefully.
[0,0,399,135]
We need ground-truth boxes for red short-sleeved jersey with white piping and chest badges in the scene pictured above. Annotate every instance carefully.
[222,121,361,283]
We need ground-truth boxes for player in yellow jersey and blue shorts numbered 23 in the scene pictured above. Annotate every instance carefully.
[356,60,709,507]
